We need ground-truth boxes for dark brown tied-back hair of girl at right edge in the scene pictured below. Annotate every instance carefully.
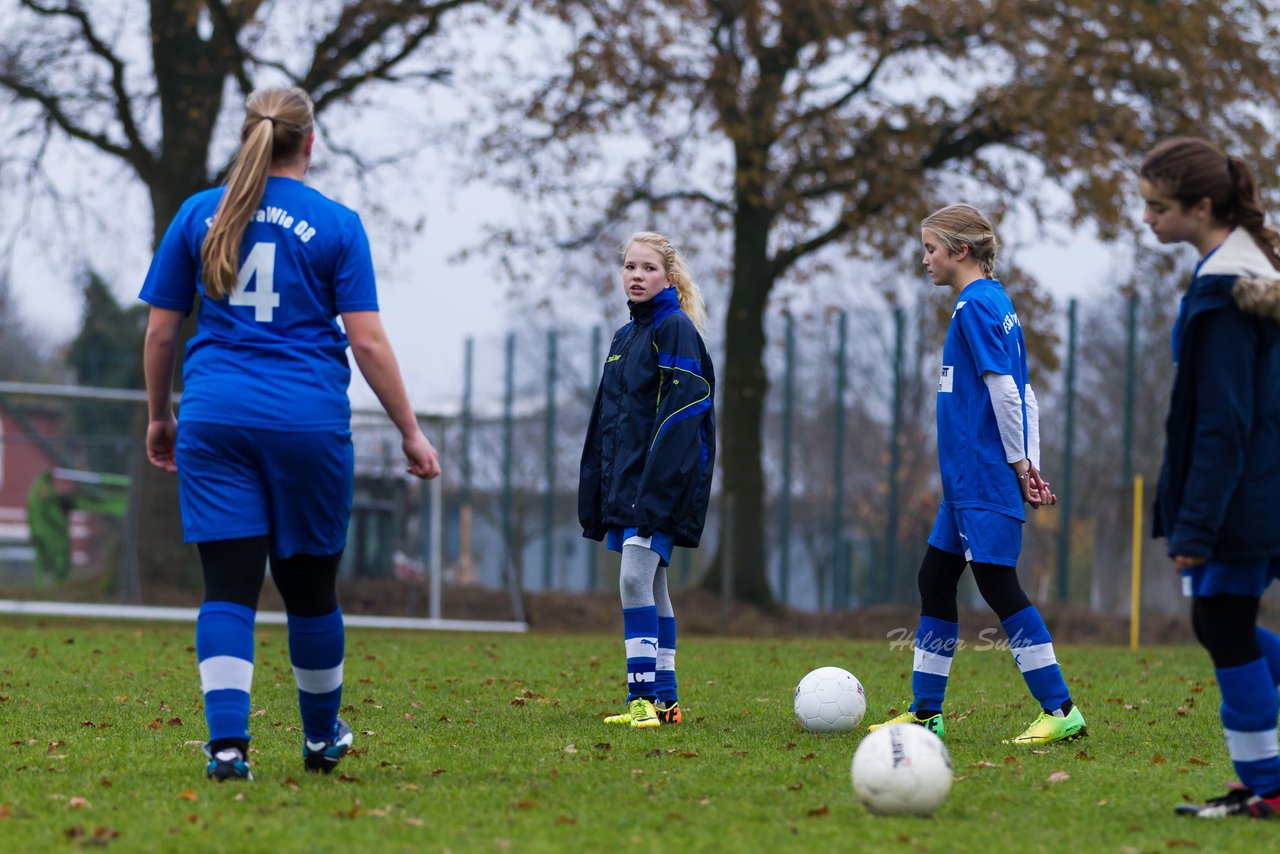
[1138,137,1280,270]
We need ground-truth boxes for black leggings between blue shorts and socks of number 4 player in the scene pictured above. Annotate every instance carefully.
[198,535,342,617]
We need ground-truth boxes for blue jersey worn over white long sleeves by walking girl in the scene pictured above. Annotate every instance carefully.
[938,279,1027,520]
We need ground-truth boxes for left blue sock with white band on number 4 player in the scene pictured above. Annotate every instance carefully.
[196,602,255,741]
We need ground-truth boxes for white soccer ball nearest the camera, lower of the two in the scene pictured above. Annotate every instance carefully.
[850,723,951,816]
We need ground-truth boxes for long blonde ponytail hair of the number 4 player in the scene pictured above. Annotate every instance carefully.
[200,88,315,300]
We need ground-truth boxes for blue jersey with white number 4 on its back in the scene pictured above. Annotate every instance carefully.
[140,177,378,430]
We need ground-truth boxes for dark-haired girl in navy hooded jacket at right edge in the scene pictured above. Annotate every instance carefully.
[1139,138,1280,818]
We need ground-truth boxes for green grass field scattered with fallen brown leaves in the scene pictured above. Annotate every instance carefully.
[0,618,1276,853]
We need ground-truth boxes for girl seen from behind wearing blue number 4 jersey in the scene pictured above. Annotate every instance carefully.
[141,88,440,782]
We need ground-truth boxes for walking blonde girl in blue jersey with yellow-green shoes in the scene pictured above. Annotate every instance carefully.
[870,205,1087,745]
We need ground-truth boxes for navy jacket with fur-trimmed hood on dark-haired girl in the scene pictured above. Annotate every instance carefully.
[1155,228,1280,560]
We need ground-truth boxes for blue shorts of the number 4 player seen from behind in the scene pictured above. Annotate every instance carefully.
[177,419,355,558]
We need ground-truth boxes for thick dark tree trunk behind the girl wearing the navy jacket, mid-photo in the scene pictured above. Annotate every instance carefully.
[703,201,774,608]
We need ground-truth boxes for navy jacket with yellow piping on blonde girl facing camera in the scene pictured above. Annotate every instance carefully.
[577,288,716,548]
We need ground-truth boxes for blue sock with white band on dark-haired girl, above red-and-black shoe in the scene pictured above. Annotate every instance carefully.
[1215,658,1280,795]
